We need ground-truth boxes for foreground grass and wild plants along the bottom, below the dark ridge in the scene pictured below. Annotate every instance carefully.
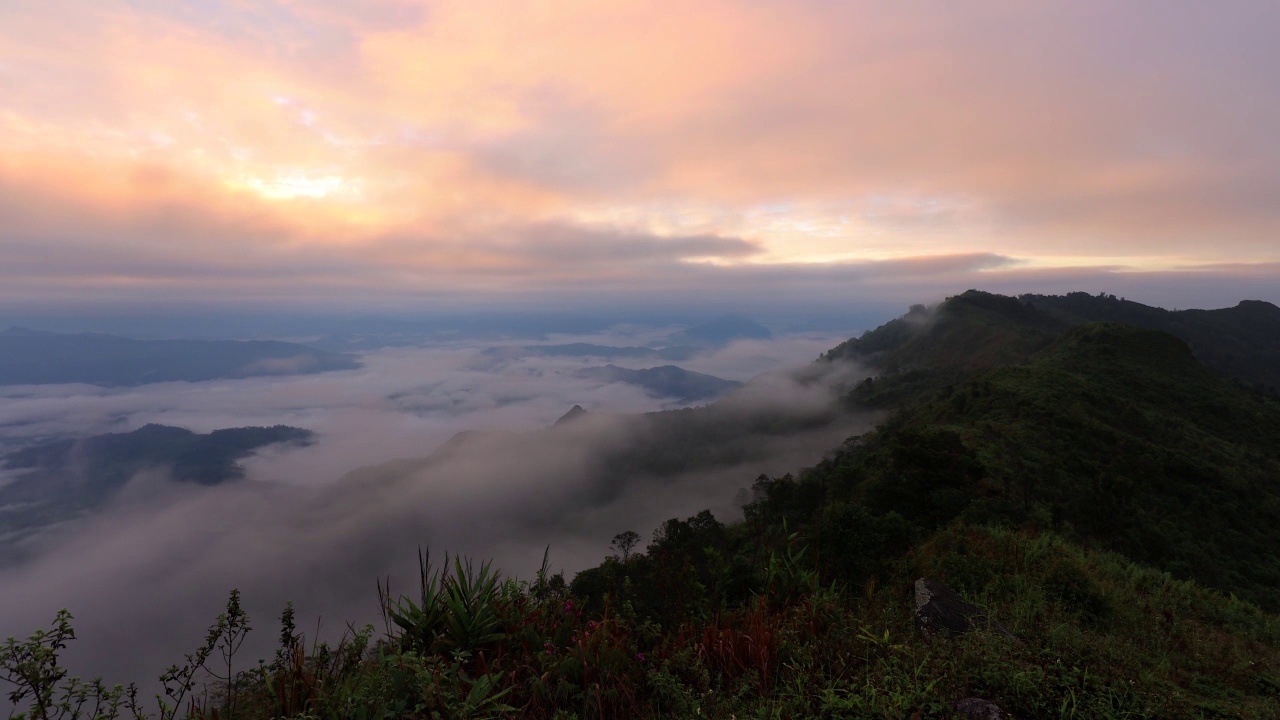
[10,523,1280,720]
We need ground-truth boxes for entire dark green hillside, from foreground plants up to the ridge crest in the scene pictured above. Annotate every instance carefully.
[0,291,1280,720]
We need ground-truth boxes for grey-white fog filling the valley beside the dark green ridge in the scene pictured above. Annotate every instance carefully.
[0,329,870,684]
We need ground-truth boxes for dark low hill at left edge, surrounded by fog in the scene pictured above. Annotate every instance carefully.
[0,424,312,534]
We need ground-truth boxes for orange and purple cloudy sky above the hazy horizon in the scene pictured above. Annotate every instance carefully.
[0,0,1280,314]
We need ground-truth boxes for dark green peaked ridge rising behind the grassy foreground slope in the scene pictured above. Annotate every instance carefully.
[801,285,1280,610]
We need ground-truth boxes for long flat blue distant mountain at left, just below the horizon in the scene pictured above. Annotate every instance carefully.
[0,328,360,386]
